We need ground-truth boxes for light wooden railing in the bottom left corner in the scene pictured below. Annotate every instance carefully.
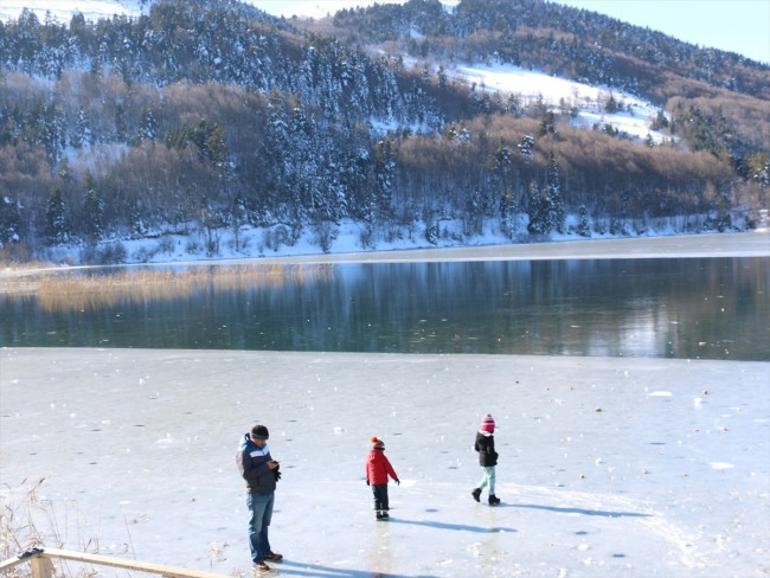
[0,548,228,578]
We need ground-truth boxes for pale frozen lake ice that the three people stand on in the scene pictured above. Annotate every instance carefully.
[0,349,770,578]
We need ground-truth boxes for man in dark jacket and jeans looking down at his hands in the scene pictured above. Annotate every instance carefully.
[236,425,283,571]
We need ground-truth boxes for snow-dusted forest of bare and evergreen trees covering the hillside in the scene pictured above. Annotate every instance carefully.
[0,0,770,260]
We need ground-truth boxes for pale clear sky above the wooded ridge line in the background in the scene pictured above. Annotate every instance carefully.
[249,0,770,64]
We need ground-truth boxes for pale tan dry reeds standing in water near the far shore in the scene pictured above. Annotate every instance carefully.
[36,265,331,312]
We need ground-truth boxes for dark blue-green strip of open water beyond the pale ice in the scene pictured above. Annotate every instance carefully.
[0,258,770,360]
